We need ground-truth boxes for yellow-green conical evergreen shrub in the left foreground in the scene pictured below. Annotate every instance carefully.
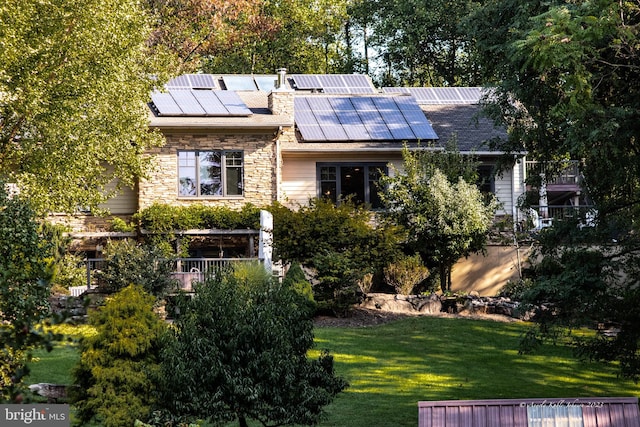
[71,285,167,427]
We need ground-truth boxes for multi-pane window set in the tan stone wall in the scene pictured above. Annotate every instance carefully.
[178,151,244,197]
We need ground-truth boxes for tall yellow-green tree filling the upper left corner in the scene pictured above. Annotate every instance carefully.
[0,0,171,211]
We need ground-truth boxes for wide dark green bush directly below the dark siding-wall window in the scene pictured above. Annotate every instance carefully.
[269,199,402,311]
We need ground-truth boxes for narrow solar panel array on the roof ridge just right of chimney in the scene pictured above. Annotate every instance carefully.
[289,74,376,94]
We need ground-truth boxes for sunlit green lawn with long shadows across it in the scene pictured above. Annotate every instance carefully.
[30,317,640,427]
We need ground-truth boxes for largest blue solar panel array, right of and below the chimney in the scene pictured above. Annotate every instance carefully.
[294,96,438,141]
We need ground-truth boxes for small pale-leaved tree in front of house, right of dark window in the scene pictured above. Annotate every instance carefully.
[381,148,497,291]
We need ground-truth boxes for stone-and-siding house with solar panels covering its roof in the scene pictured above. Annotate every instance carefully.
[57,69,588,290]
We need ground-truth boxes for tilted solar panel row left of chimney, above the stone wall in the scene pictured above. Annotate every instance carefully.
[151,89,252,117]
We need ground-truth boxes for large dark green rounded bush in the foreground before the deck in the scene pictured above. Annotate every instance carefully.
[160,263,346,426]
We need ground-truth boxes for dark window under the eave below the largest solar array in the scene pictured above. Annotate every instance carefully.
[317,163,387,209]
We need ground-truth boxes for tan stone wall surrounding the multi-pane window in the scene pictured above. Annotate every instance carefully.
[139,133,276,210]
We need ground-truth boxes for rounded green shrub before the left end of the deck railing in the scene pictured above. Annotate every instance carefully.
[95,239,177,297]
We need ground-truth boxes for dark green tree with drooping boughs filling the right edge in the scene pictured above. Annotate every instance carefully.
[473,0,640,379]
